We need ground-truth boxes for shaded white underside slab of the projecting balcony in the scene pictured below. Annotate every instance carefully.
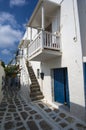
[29,48,62,61]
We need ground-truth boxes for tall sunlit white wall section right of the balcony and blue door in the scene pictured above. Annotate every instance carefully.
[61,0,85,113]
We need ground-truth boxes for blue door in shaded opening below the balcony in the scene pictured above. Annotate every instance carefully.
[54,68,70,106]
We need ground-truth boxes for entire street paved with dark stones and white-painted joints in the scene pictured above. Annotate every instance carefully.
[0,87,86,130]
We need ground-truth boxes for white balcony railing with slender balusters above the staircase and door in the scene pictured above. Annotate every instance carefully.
[28,31,60,56]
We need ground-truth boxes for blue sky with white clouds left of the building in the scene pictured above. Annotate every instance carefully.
[0,0,38,64]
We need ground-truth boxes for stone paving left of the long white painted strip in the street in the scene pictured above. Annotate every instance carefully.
[0,91,59,130]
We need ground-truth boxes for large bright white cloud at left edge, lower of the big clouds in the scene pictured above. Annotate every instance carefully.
[0,25,23,48]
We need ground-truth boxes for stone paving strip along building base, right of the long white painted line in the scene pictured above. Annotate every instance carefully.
[36,101,86,130]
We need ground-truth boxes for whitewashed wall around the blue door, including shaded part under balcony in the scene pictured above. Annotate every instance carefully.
[42,0,85,120]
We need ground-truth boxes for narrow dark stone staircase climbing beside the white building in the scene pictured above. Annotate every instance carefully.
[28,66,44,101]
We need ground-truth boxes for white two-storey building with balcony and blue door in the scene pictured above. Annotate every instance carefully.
[17,0,86,120]
